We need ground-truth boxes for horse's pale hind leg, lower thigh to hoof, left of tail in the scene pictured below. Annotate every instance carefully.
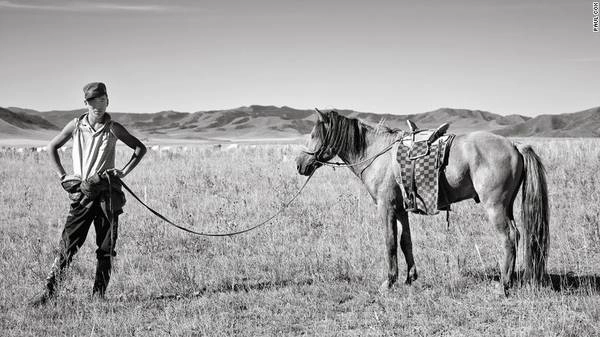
[486,203,519,294]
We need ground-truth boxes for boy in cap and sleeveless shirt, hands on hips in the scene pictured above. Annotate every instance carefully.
[31,82,146,306]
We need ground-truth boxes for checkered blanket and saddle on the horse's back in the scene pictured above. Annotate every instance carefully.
[396,126,454,215]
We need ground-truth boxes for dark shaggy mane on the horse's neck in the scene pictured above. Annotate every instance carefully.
[318,110,396,156]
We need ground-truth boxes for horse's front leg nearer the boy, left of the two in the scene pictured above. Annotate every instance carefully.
[377,201,398,290]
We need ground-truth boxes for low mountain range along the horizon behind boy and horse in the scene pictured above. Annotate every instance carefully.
[0,105,600,140]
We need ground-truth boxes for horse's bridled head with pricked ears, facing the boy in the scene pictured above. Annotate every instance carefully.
[296,109,337,176]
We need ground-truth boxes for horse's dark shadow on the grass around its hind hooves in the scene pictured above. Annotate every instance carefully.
[462,268,600,293]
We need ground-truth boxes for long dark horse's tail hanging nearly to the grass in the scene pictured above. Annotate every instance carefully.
[517,145,550,285]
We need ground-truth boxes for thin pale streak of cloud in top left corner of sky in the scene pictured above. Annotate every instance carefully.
[0,0,177,12]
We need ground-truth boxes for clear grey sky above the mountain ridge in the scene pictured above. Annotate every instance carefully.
[0,0,600,116]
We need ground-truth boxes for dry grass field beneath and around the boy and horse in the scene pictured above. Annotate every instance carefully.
[0,139,600,336]
